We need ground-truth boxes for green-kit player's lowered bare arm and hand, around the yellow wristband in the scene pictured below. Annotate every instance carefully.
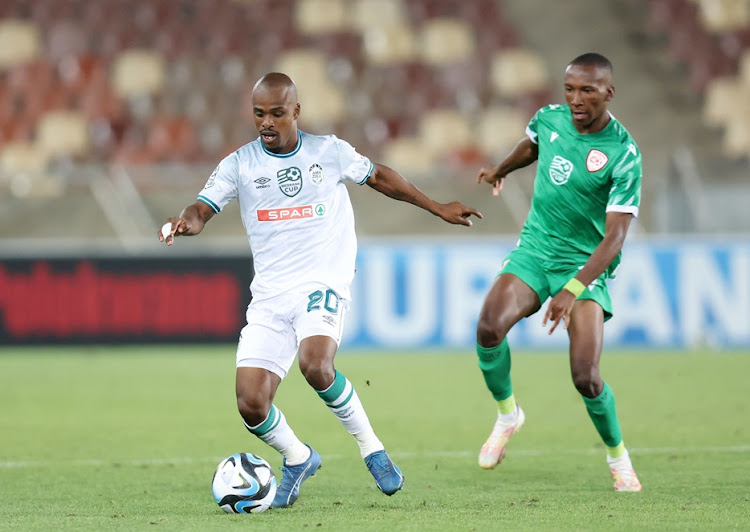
[542,212,633,334]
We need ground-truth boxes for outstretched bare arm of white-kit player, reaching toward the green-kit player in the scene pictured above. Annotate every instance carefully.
[367,164,482,227]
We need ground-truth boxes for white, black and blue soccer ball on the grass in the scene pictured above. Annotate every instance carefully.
[211,453,276,514]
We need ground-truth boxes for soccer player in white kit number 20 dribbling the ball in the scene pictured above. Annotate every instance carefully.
[159,72,482,508]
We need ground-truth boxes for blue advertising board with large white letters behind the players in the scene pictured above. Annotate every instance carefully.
[343,238,750,349]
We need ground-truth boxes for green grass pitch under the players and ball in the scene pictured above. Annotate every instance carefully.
[0,346,750,531]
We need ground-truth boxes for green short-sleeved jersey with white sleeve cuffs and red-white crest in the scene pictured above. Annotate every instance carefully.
[521,105,642,277]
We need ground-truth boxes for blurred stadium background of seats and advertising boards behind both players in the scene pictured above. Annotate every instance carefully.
[0,0,750,348]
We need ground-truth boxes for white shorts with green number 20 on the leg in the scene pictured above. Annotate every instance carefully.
[237,284,349,379]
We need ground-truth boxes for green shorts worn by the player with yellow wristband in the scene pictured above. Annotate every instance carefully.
[500,247,612,321]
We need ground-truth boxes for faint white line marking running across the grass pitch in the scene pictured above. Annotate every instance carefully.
[0,445,750,469]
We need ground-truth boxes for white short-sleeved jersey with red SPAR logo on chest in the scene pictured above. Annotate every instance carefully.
[198,131,374,300]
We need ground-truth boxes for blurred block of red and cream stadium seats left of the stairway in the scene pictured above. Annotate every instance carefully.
[0,0,548,179]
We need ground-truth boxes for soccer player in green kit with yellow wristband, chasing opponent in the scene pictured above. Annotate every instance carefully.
[477,53,642,491]
